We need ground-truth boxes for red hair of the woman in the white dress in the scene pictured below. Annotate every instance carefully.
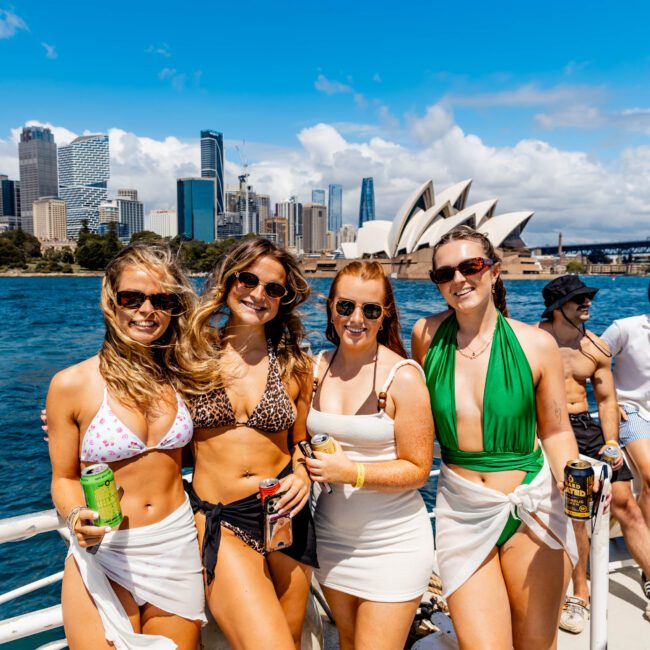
[325,261,407,358]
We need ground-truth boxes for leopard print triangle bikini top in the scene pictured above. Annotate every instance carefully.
[190,341,296,433]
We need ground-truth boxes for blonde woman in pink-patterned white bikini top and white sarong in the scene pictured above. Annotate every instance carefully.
[47,244,205,650]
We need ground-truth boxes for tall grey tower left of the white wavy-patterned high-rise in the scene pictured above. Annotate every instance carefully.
[18,126,58,234]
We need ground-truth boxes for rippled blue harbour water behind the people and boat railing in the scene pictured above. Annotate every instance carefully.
[0,277,648,650]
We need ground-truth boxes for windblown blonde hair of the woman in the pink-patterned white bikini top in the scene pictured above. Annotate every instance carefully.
[99,242,197,413]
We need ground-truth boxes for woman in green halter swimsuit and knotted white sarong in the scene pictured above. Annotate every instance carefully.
[412,226,578,650]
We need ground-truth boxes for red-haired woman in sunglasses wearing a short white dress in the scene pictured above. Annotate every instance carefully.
[307,262,433,650]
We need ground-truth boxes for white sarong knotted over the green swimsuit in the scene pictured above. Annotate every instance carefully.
[436,459,578,597]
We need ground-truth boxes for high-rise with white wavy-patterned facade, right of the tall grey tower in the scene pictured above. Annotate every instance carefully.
[59,134,111,239]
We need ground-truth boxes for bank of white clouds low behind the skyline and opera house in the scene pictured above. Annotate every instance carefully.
[0,110,650,244]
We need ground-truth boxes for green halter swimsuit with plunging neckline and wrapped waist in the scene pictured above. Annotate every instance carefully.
[424,313,544,546]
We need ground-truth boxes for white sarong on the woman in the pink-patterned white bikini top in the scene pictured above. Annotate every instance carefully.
[68,499,207,650]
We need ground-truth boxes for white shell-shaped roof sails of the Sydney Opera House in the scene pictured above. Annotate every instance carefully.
[342,179,533,259]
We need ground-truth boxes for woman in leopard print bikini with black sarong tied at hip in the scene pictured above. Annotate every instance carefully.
[182,238,317,650]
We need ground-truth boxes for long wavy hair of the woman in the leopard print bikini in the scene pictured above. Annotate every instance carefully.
[179,237,311,395]
